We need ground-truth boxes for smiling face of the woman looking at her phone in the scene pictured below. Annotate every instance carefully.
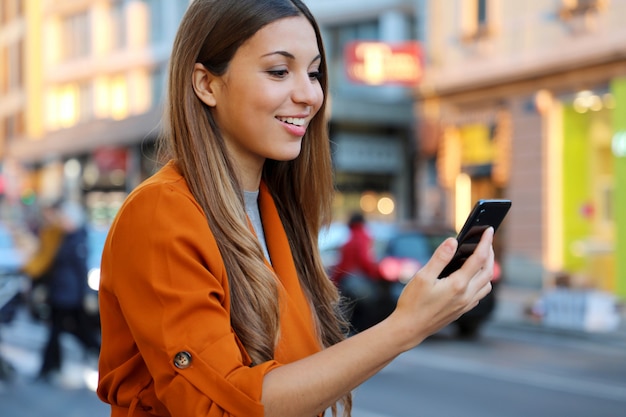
[201,17,324,185]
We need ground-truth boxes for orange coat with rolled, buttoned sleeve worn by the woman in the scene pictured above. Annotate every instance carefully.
[98,163,320,417]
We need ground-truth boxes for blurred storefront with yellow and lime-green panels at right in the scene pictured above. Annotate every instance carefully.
[421,73,626,297]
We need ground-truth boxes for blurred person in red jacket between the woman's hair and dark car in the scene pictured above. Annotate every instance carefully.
[330,212,385,332]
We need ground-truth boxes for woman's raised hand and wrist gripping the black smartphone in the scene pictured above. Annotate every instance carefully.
[388,227,494,350]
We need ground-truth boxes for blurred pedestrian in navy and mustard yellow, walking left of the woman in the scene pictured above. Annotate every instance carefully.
[22,200,100,382]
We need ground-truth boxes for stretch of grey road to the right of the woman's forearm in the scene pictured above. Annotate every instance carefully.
[354,327,626,417]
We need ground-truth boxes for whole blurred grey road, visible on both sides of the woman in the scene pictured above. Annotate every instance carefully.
[0,306,626,417]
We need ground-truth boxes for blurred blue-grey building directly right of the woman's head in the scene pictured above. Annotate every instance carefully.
[306,0,421,222]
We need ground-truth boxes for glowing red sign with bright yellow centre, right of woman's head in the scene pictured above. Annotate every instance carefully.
[344,41,423,87]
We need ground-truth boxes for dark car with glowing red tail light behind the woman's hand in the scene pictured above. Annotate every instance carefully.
[379,225,500,338]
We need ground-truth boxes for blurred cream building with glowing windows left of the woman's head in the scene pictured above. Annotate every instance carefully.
[0,0,187,223]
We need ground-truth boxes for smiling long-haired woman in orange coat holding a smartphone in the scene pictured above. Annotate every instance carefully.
[98,0,493,417]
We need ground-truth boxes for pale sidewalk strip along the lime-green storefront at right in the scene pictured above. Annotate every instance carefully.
[490,284,626,348]
